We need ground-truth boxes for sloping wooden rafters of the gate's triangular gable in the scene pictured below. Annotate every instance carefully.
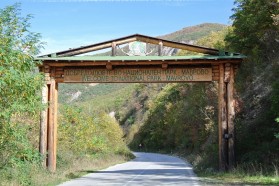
[40,34,226,57]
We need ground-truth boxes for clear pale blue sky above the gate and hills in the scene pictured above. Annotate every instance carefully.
[0,0,234,54]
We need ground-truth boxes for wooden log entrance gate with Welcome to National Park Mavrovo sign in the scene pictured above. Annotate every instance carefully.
[36,34,243,172]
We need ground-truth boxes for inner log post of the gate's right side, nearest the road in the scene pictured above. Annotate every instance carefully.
[218,64,228,171]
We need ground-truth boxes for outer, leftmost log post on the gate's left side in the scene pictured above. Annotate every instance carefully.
[39,83,49,167]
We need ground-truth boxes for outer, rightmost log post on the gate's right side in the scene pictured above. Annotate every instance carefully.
[227,65,235,170]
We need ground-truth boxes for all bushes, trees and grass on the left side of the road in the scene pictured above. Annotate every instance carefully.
[0,4,133,186]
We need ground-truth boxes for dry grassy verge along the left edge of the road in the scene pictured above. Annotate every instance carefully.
[0,153,131,186]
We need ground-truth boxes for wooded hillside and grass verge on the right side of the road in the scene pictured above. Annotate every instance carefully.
[114,0,279,185]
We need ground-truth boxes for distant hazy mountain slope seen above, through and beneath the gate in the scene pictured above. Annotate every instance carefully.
[59,23,226,103]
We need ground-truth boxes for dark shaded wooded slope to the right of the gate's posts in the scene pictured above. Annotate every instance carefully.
[219,0,279,167]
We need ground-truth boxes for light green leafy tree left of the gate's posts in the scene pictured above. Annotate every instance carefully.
[0,4,42,172]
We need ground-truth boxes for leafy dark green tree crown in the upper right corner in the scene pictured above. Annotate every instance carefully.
[226,0,279,61]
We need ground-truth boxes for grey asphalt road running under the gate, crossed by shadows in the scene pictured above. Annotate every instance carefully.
[60,152,199,186]
